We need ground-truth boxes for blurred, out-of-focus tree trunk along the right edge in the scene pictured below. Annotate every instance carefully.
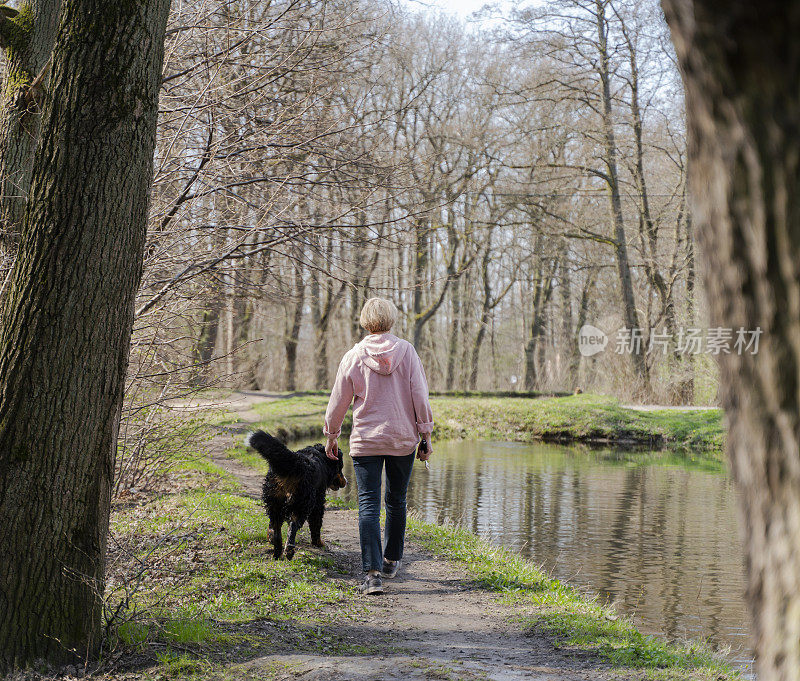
[663,0,800,681]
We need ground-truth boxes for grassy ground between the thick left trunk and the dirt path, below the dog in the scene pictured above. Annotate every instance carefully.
[101,452,369,679]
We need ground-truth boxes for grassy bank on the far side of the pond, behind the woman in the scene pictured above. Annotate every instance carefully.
[239,395,725,454]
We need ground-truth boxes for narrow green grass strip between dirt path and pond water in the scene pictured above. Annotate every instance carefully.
[408,516,740,680]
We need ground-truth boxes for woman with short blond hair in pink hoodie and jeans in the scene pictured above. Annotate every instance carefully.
[323,298,433,594]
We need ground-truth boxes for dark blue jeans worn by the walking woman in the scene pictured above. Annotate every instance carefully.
[353,452,414,572]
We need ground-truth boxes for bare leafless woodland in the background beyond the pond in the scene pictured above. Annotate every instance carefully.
[1,0,708,488]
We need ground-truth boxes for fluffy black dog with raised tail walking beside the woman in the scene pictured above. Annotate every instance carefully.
[246,430,347,560]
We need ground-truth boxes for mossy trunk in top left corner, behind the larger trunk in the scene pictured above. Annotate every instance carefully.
[0,0,61,254]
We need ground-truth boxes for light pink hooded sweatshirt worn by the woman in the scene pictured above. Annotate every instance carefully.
[323,333,433,456]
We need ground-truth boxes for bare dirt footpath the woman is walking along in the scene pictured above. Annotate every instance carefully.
[205,402,609,681]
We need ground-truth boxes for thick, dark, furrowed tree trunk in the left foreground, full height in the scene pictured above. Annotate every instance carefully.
[0,0,169,669]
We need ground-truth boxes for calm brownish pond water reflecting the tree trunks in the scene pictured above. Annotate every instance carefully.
[322,442,750,664]
